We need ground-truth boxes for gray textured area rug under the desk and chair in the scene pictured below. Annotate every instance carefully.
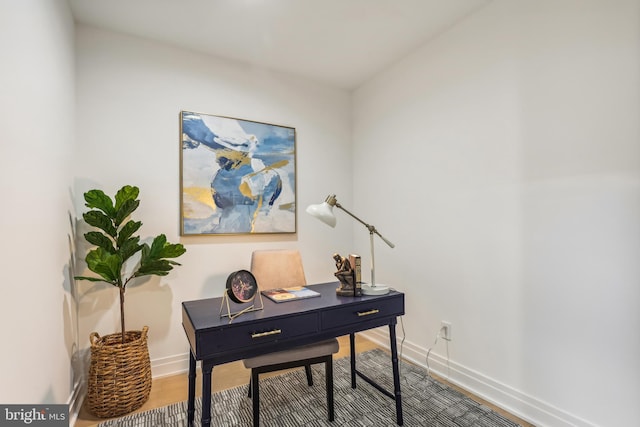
[99,349,518,427]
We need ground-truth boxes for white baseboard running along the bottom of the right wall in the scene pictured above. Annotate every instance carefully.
[362,328,595,427]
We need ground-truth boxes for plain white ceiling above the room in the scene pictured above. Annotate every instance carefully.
[69,0,490,89]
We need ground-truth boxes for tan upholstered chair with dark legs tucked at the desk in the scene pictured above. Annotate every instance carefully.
[244,250,338,426]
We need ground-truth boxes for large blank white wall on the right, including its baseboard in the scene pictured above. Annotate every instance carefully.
[353,0,640,426]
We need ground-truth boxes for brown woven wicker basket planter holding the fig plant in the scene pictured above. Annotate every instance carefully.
[87,326,151,418]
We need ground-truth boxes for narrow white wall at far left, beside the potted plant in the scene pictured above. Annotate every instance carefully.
[0,0,78,404]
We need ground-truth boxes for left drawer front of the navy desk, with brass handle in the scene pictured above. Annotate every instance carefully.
[198,313,319,354]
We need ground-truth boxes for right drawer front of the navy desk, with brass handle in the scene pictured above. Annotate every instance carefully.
[321,295,404,330]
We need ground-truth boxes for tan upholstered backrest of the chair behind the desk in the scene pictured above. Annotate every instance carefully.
[251,249,307,290]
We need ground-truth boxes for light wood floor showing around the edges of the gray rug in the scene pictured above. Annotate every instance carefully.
[74,334,534,427]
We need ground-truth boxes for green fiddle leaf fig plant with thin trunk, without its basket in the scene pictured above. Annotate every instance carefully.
[75,185,186,344]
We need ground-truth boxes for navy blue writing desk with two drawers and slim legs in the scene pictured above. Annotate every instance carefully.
[182,282,404,427]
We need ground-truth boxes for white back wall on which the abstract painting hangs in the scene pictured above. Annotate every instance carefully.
[74,27,351,375]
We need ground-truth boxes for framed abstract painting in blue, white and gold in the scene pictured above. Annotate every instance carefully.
[180,111,296,236]
